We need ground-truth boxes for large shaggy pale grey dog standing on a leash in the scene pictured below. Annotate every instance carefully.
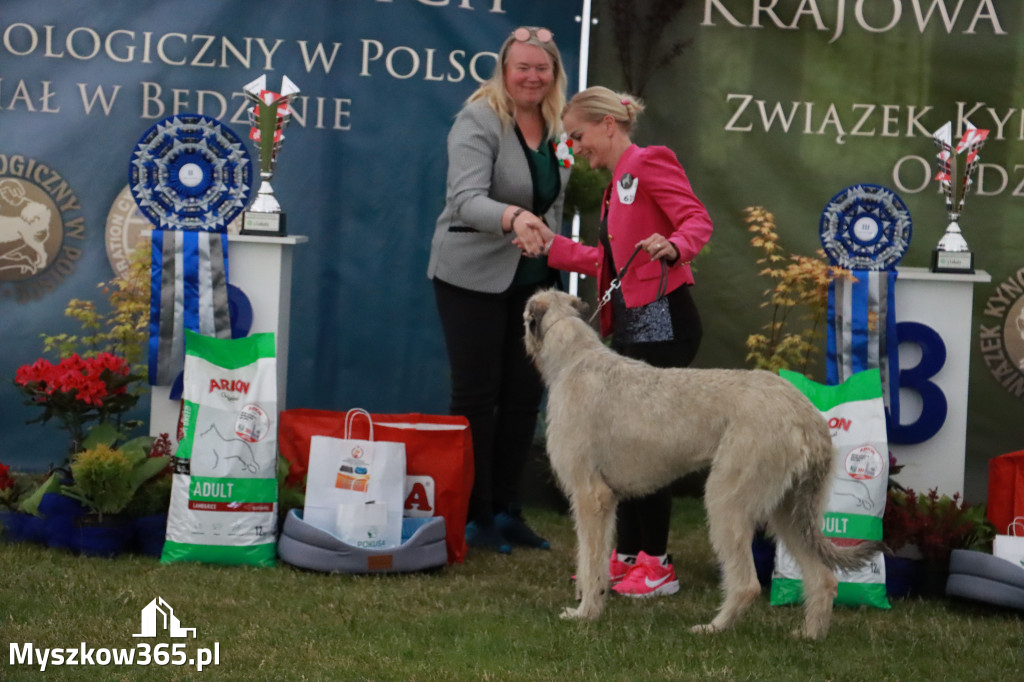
[523,291,880,638]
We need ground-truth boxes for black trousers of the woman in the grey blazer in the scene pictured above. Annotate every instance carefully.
[433,278,547,523]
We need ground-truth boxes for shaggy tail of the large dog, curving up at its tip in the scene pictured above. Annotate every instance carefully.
[782,458,885,571]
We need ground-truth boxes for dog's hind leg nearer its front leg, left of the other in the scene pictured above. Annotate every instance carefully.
[690,470,761,633]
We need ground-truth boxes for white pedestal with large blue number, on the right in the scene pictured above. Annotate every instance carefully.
[889,267,992,495]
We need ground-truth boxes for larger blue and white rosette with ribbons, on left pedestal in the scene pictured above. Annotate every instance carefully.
[128,114,253,386]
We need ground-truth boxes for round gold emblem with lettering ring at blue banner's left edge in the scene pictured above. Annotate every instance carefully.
[0,154,85,303]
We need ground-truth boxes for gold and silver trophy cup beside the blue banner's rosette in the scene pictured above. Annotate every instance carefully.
[242,75,299,237]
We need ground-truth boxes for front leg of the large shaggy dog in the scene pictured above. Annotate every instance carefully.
[562,476,616,621]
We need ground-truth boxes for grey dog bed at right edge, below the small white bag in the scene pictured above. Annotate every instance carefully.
[946,550,1024,610]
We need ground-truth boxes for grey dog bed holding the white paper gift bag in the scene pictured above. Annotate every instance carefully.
[278,509,447,573]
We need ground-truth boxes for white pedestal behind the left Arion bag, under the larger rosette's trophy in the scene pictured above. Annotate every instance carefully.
[150,235,309,441]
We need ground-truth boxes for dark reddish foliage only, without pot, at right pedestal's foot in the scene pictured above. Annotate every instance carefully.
[882,486,995,561]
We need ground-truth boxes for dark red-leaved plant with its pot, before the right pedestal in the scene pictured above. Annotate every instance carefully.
[882,485,995,596]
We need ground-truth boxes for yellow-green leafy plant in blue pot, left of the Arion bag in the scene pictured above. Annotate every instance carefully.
[60,443,170,556]
